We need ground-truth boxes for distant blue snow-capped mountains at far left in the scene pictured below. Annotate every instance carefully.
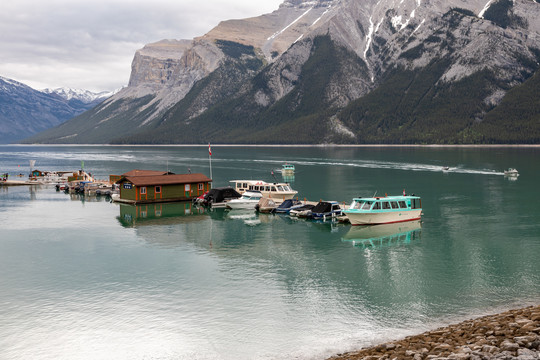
[0,77,113,143]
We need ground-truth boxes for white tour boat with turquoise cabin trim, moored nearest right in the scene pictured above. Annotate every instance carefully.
[343,195,422,225]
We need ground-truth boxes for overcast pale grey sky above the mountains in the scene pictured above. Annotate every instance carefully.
[0,0,283,91]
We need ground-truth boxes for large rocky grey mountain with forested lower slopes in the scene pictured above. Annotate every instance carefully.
[28,0,540,143]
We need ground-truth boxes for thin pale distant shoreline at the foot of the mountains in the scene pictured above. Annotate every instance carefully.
[5,143,540,148]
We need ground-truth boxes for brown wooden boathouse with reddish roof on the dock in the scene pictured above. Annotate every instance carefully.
[116,170,212,204]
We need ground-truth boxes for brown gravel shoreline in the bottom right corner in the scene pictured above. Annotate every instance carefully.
[329,305,540,360]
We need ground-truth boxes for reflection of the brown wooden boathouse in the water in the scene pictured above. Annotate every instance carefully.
[117,202,207,227]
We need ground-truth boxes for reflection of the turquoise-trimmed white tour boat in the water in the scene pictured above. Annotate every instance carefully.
[341,220,422,248]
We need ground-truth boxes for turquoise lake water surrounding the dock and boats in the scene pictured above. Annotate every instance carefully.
[0,146,540,359]
